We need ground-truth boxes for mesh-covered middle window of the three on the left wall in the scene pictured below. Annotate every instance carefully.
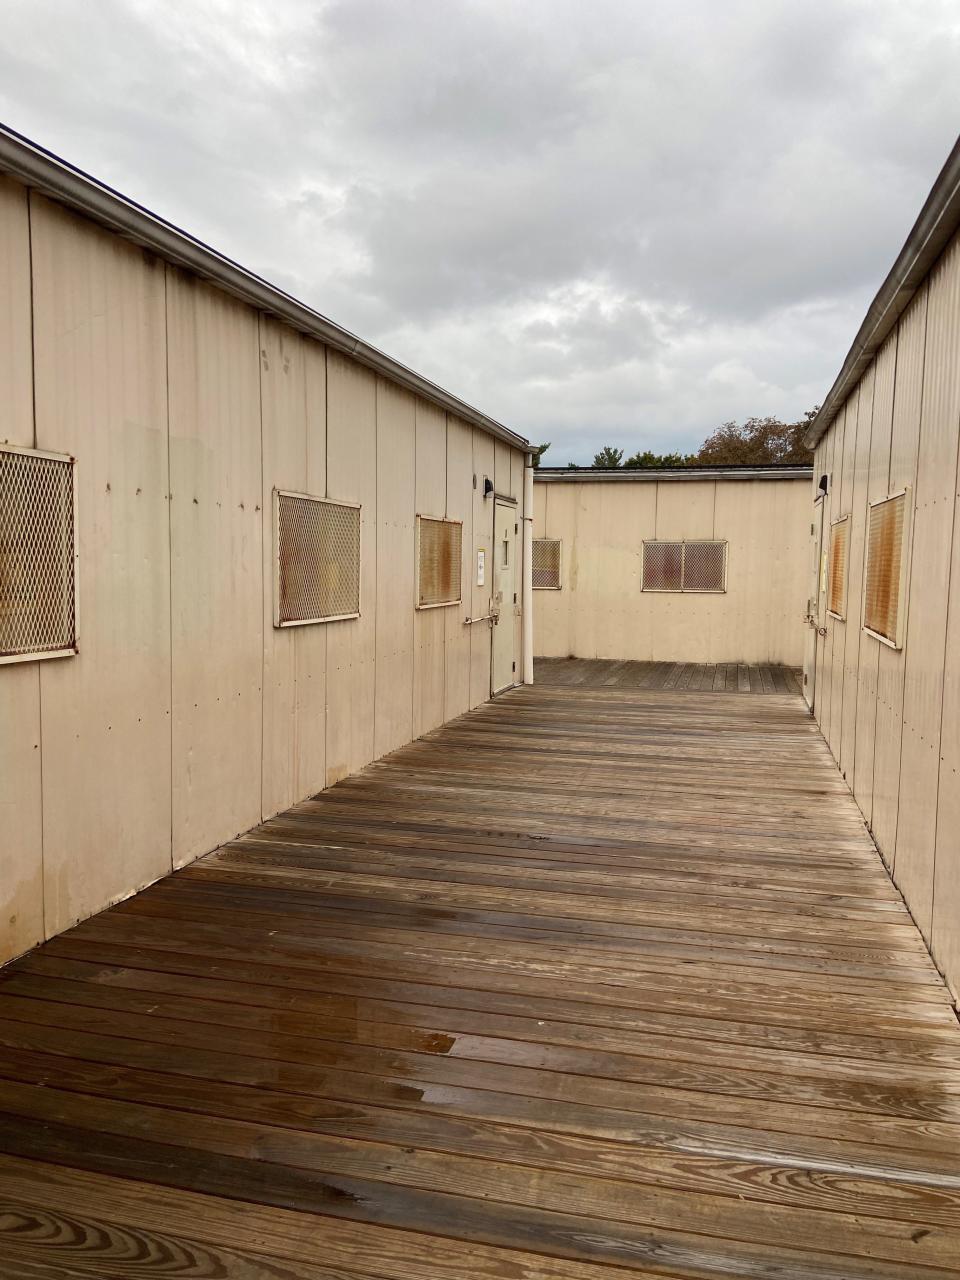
[275,492,360,627]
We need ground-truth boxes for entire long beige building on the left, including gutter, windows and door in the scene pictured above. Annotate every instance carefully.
[0,131,531,961]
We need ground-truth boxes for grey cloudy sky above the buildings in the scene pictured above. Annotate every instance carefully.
[0,0,960,463]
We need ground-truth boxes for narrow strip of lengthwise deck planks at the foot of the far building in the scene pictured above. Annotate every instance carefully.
[534,658,801,694]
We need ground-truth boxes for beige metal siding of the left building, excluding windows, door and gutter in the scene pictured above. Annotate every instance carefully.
[0,180,522,960]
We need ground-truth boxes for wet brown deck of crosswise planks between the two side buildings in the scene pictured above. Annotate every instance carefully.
[0,682,960,1280]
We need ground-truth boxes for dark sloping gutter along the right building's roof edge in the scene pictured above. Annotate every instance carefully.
[804,131,960,449]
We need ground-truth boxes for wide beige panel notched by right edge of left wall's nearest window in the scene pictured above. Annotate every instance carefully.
[31,197,170,933]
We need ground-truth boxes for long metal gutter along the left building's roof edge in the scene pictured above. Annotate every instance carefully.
[0,124,530,449]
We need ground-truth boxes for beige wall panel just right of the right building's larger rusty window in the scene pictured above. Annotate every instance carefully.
[895,241,960,941]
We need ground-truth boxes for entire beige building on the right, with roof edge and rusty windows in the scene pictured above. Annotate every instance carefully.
[805,135,960,992]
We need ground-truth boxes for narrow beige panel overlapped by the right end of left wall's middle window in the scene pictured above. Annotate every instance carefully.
[326,351,376,786]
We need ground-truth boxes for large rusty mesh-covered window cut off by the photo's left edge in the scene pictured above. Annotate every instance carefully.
[0,445,77,662]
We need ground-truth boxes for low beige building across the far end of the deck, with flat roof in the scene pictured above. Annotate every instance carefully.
[532,466,812,667]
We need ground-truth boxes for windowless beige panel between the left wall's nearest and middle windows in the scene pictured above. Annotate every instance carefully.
[166,268,263,867]
